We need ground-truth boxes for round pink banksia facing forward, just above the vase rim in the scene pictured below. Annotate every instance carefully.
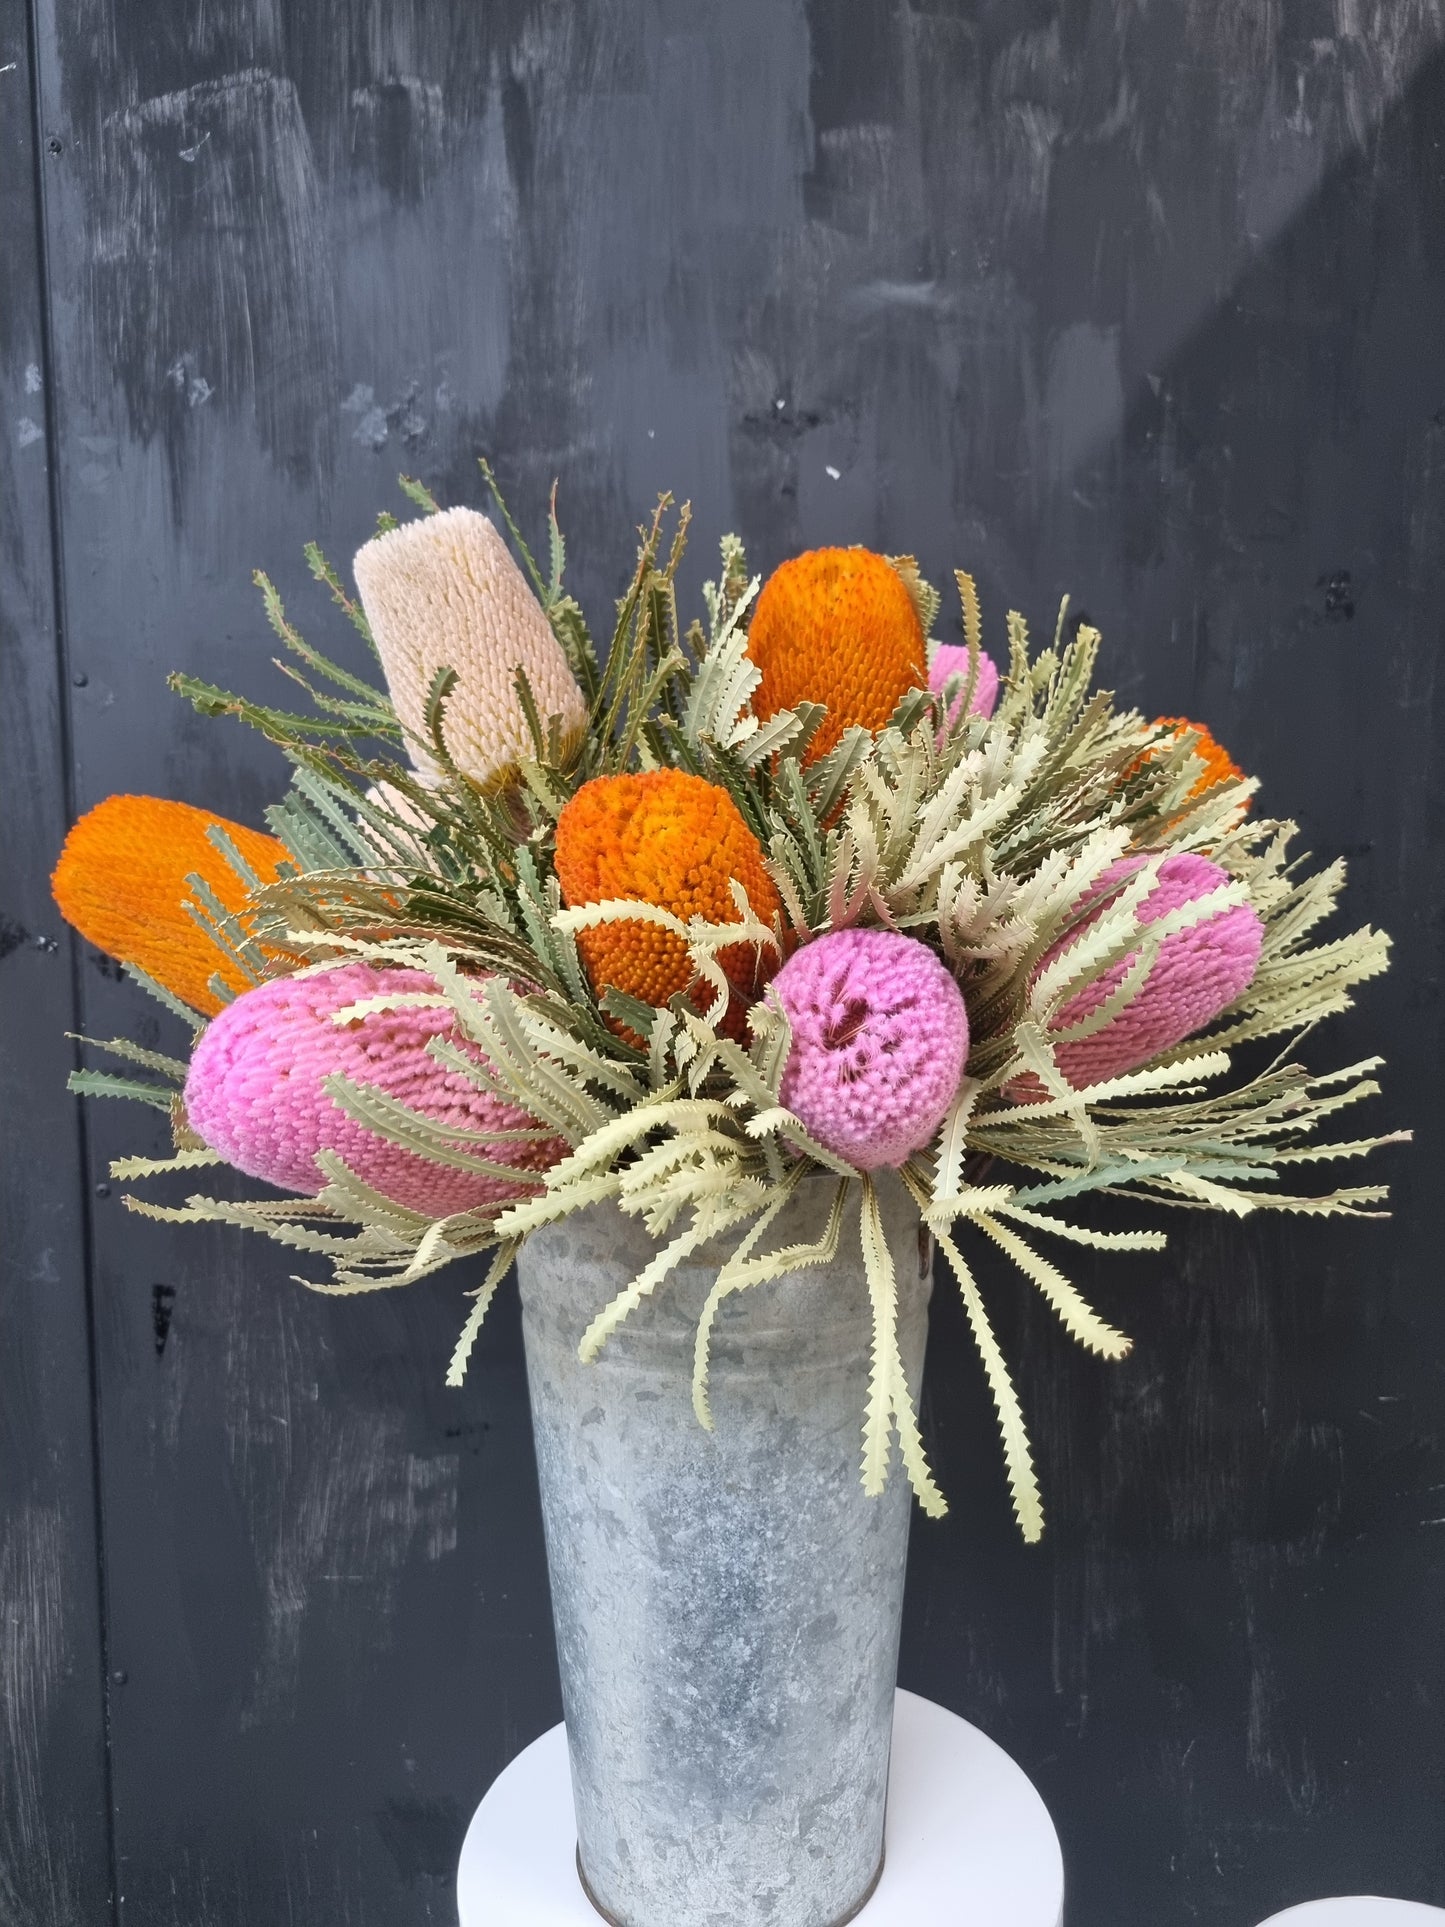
[773,929,969,1172]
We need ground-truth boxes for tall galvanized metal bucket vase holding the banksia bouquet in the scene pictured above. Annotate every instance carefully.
[518,1174,931,1927]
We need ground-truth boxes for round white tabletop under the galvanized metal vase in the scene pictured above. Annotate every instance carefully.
[457,1692,1071,1927]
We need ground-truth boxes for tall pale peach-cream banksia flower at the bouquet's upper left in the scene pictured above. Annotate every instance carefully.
[355,509,588,790]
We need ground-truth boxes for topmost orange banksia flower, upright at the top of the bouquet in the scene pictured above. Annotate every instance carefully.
[748,549,929,763]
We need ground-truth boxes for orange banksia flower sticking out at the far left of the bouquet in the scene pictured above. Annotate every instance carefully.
[50,796,285,1016]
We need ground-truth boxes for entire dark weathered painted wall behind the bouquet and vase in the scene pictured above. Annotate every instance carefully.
[0,0,1445,1927]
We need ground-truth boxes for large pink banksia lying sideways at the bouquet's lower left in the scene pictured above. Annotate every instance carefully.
[185,964,566,1218]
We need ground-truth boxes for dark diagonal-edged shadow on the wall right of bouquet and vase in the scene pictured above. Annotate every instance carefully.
[904,37,1445,1927]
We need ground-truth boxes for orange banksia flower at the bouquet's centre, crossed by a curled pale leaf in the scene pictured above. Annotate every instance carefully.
[557,769,780,1043]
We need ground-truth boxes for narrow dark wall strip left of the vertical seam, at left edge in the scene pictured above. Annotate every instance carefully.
[0,0,110,1927]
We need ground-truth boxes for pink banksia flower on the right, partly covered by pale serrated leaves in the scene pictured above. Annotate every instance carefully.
[1013,852,1264,1096]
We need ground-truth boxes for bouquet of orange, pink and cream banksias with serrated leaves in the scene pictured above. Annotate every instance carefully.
[54,470,1403,1540]
